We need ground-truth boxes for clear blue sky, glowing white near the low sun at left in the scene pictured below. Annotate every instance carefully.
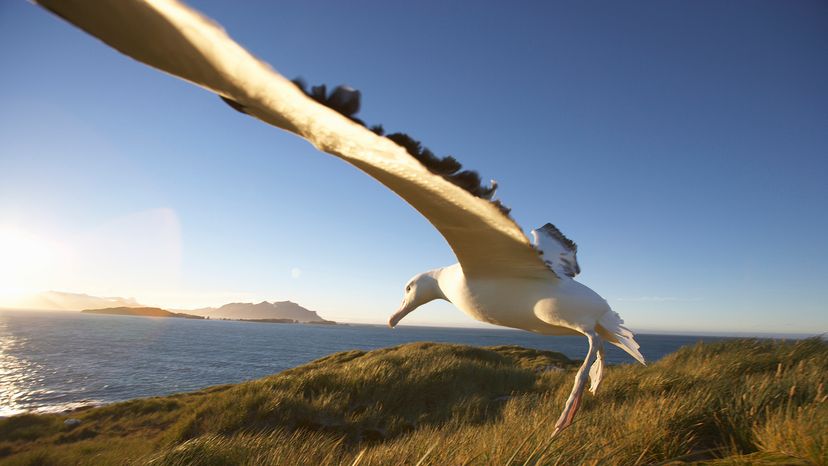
[0,1,828,333]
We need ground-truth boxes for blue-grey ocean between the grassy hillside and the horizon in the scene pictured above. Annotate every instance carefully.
[0,310,736,417]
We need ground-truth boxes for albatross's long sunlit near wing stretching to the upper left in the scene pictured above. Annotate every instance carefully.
[38,0,554,279]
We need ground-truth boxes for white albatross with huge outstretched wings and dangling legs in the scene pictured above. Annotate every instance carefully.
[37,0,644,435]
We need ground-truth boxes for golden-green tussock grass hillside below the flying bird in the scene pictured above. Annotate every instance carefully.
[0,339,828,465]
